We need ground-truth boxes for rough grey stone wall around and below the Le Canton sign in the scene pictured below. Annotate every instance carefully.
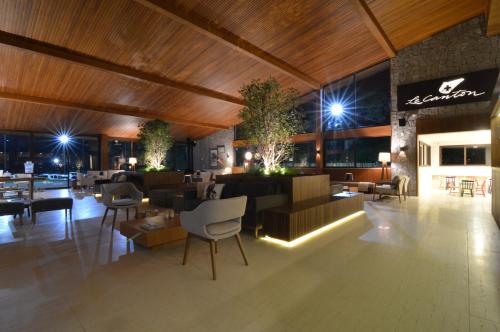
[391,16,500,195]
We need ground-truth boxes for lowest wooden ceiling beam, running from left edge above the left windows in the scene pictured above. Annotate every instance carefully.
[0,92,228,130]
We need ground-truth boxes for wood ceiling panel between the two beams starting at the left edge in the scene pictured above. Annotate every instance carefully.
[0,46,240,126]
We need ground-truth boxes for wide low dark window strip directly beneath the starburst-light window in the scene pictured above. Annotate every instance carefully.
[324,136,391,168]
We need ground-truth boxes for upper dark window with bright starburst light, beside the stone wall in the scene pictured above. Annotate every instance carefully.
[323,62,391,131]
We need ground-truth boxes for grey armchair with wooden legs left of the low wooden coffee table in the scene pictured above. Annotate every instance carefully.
[101,182,143,229]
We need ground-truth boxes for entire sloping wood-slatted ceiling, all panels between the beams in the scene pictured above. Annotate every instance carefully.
[0,0,487,138]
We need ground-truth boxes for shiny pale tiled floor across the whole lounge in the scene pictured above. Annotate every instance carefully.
[0,191,500,331]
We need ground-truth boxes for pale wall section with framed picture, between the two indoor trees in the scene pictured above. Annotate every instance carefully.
[193,127,234,170]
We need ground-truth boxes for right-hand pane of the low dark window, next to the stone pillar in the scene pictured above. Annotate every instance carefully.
[355,137,391,168]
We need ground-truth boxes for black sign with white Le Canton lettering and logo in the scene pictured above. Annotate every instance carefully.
[398,68,498,111]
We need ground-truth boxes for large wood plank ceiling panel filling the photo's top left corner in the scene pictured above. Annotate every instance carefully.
[0,0,308,96]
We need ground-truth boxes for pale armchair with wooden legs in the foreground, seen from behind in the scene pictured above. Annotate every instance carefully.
[180,196,248,280]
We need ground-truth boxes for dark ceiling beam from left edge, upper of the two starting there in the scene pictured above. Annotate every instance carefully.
[0,31,244,105]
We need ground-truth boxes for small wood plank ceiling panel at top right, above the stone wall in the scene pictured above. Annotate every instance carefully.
[368,0,488,49]
